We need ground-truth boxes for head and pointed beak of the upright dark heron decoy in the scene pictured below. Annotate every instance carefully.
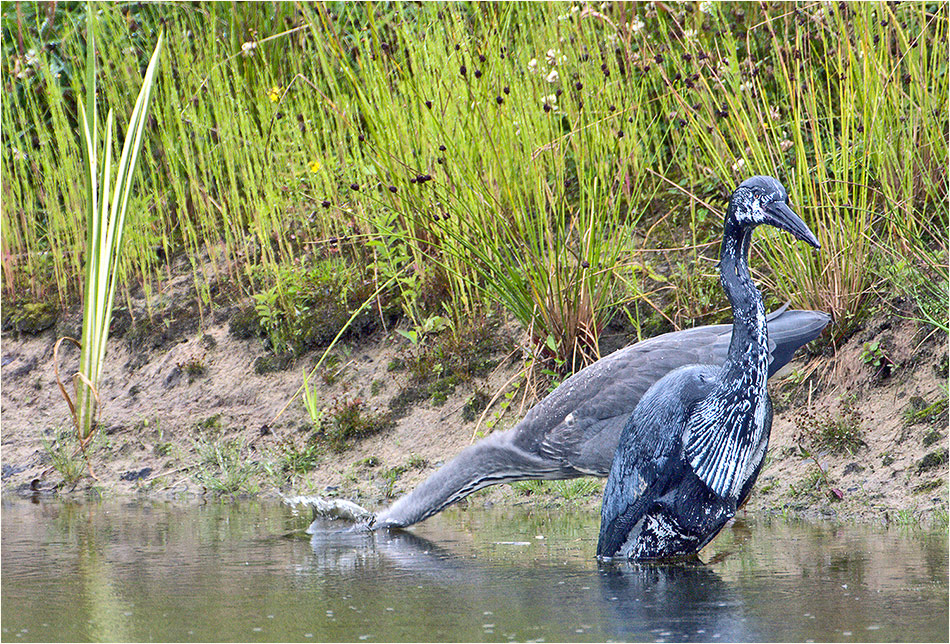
[726,175,821,248]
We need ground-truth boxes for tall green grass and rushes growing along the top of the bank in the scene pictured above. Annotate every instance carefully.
[0,3,948,374]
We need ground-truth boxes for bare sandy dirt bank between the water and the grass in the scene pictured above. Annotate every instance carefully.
[0,276,948,522]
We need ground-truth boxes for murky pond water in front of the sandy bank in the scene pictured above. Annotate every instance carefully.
[0,498,948,642]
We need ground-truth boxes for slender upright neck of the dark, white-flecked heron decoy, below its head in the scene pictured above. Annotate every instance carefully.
[719,217,769,377]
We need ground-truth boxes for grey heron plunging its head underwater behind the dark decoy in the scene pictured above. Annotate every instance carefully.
[376,307,830,527]
